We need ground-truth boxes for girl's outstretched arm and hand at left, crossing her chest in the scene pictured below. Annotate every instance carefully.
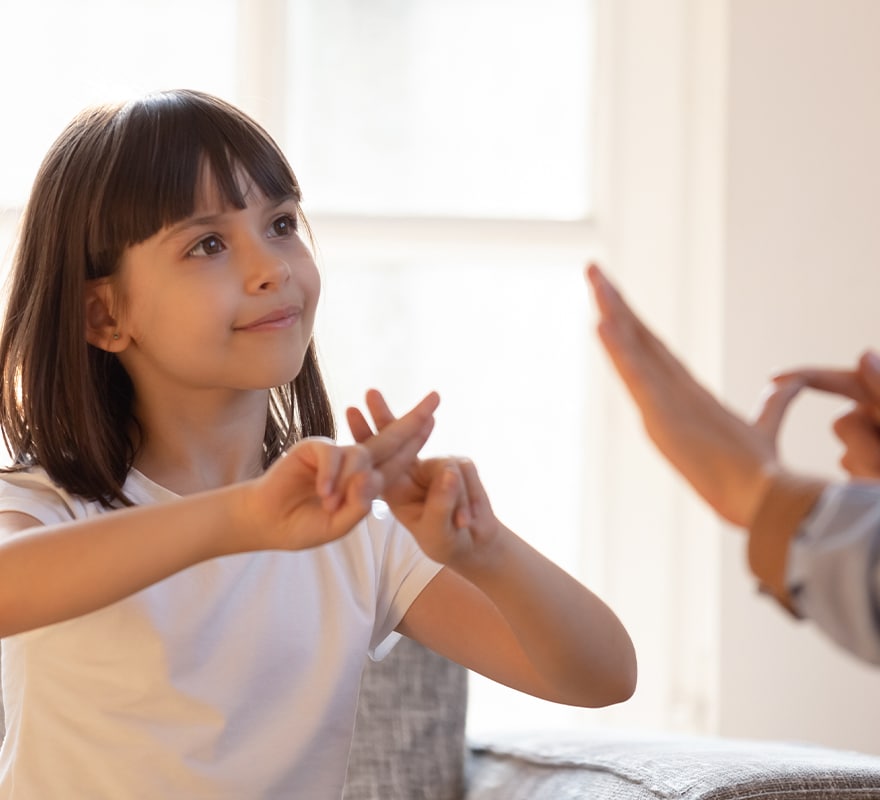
[0,394,439,637]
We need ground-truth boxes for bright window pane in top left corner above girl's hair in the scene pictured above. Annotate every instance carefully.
[0,0,236,207]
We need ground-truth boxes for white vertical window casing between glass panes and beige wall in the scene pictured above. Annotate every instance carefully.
[585,0,727,733]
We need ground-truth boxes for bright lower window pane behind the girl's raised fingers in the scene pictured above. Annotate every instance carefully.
[316,255,589,570]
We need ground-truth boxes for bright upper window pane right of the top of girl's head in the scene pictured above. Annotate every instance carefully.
[287,0,595,219]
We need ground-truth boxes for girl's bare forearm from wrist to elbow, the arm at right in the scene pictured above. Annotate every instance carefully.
[455,526,637,706]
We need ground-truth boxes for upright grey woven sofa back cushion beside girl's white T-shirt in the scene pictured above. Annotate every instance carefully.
[344,638,467,800]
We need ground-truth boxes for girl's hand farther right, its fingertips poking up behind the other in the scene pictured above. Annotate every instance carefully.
[346,389,500,566]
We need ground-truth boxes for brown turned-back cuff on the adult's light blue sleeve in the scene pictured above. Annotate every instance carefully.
[748,472,826,616]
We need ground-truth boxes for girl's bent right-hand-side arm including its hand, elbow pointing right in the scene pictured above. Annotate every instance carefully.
[348,392,636,706]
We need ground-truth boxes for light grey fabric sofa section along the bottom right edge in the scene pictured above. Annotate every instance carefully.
[467,731,880,800]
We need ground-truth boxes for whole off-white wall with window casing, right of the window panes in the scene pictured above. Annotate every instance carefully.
[586,0,880,753]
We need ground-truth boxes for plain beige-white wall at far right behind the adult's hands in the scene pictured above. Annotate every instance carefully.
[717,0,880,753]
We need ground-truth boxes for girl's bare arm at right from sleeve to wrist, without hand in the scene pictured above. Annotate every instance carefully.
[398,512,637,708]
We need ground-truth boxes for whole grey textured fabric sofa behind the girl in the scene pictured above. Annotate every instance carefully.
[345,639,880,800]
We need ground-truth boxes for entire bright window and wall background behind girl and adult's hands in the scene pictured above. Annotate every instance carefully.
[0,0,880,752]
